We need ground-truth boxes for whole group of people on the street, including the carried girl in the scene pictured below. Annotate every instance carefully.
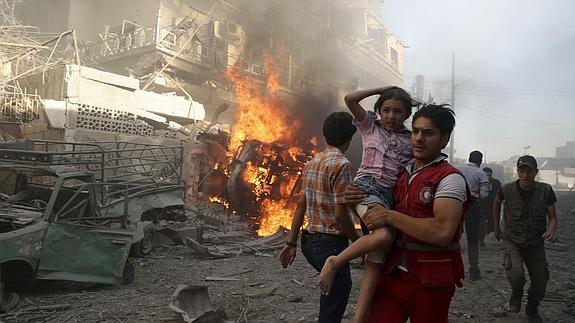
[279,86,557,323]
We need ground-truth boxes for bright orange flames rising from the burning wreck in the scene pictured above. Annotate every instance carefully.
[226,57,310,236]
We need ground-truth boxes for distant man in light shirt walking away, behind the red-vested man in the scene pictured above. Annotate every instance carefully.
[459,150,489,280]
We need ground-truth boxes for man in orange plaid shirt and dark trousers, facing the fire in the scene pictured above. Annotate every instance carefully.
[279,112,359,323]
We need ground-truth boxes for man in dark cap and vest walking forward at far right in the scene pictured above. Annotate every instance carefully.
[493,155,557,322]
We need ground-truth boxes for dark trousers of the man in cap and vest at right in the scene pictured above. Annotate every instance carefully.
[503,241,549,305]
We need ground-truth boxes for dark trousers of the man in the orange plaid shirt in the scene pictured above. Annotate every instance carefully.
[301,233,351,323]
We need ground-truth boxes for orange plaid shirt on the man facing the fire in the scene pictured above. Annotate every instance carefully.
[302,146,353,234]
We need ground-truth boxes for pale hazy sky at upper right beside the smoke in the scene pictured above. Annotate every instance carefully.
[382,0,575,162]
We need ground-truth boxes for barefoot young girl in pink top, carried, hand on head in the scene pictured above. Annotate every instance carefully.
[319,86,417,322]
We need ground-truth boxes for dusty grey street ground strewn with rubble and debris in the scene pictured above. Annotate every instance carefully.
[0,193,575,322]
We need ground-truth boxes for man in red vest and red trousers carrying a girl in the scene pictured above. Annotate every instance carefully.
[345,105,468,323]
